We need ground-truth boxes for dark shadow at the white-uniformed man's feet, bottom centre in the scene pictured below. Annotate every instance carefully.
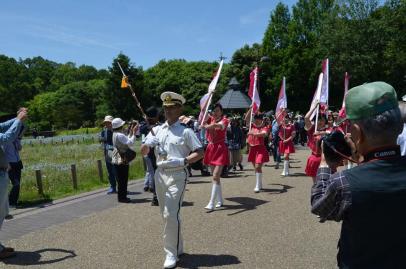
[177,254,241,269]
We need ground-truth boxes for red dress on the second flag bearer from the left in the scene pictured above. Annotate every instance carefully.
[248,124,269,163]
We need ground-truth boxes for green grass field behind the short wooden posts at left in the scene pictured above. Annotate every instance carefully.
[20,140,144,205]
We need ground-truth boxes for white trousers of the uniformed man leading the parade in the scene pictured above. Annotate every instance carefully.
[155,168,187,257]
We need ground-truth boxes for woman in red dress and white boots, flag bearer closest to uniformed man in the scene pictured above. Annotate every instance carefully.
[203,104,230,211]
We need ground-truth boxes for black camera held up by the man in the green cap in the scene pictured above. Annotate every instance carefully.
[322,131,352,164]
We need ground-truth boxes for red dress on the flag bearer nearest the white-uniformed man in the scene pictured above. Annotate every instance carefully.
[203,116,230,166]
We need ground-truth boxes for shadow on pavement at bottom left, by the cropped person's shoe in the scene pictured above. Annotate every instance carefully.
[3,248,76,265]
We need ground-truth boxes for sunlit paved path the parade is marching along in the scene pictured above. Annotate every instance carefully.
[0,149,339,269]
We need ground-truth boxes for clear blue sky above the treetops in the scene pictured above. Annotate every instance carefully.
[0,0,296,69]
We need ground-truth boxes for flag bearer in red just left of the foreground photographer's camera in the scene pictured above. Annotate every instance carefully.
[304,104,327,183]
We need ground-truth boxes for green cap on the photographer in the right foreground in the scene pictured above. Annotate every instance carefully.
[345,81,398,120]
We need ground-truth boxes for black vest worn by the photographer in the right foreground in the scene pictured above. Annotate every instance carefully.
[338,156,406,269]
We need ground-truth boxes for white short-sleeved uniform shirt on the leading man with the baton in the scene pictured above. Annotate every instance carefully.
[146,121,203,161]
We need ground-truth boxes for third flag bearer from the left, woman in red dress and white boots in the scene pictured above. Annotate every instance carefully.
[278,116,296,176]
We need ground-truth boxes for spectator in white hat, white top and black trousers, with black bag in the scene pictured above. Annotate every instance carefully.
[111,118,138,203]
